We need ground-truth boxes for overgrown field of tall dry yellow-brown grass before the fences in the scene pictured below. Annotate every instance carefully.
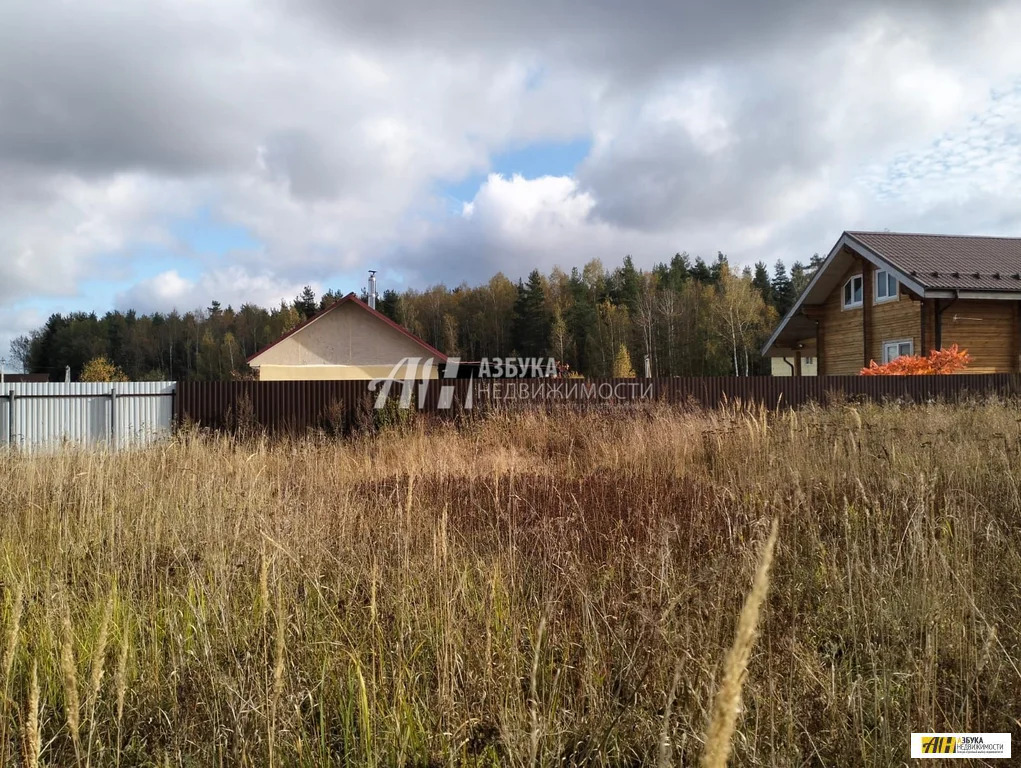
[0,404,1021,766]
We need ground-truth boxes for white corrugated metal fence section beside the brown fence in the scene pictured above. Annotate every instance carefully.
[0,381,175,450]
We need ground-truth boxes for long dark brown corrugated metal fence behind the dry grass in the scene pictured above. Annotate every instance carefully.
[176,374,1021,433]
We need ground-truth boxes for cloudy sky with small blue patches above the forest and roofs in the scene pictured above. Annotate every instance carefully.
[0,0,1021,363]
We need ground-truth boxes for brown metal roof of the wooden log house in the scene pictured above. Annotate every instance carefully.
[846,232,1021,291]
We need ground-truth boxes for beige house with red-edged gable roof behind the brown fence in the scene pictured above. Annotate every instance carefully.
[248,293,446,381]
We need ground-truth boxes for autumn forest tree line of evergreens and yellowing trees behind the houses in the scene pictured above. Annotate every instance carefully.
[11,253,820,381]
